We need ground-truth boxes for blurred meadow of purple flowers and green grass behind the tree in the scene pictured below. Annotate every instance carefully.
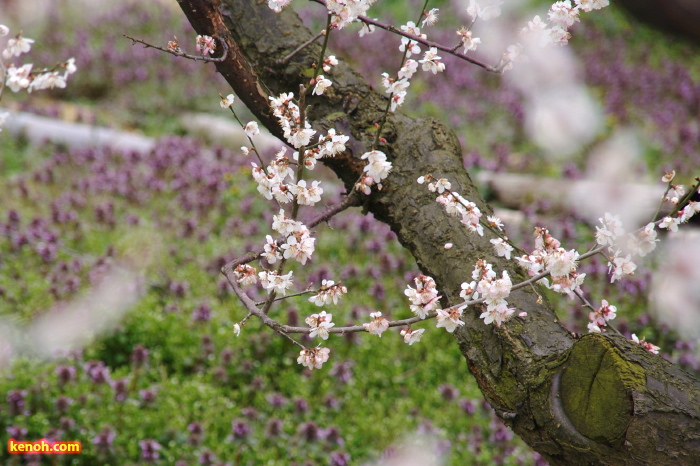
[0,0,700,466]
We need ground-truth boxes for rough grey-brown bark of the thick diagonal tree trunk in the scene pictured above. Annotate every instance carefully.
[179,0,700,465]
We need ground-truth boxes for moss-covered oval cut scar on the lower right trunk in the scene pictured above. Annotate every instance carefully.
[561,335,645,446]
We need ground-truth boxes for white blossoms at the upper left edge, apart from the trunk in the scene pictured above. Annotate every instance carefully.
[0,24,77,131]
